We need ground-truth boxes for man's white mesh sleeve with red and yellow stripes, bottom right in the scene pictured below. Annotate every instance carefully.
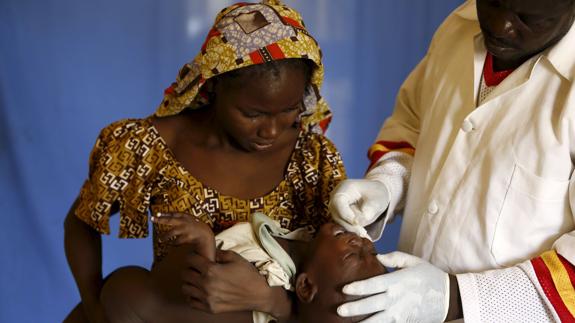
[457,250,575,322]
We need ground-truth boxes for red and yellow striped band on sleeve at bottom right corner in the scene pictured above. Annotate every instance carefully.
[531,250,575,322]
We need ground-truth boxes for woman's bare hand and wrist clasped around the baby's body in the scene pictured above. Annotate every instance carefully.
[182,250,291,318]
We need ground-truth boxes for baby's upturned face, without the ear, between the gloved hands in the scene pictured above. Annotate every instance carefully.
[305,223,386,322]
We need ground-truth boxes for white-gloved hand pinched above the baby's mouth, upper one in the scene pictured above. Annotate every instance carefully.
[329,178,390,229]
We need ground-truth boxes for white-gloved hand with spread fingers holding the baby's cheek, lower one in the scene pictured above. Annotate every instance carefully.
[337,251,449,323]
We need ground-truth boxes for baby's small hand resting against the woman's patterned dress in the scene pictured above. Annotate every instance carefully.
[152,213,214,245]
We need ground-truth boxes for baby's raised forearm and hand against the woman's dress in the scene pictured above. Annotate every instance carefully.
[152,213,216,261]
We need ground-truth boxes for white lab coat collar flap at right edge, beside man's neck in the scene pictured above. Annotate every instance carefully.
[543,23,575,82]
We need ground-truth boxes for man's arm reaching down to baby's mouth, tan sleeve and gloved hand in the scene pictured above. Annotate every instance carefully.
[330,54,429,240]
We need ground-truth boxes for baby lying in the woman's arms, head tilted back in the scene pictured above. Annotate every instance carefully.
[104,213,385,323]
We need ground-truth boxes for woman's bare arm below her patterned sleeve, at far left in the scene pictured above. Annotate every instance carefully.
[64,200,110,322]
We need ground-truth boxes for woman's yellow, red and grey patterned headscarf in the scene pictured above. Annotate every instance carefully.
[156,1,331,132]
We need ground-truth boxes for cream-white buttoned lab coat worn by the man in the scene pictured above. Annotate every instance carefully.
[378,1,575,322]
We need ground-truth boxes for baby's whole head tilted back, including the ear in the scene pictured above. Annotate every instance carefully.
[295,223,386,322]
